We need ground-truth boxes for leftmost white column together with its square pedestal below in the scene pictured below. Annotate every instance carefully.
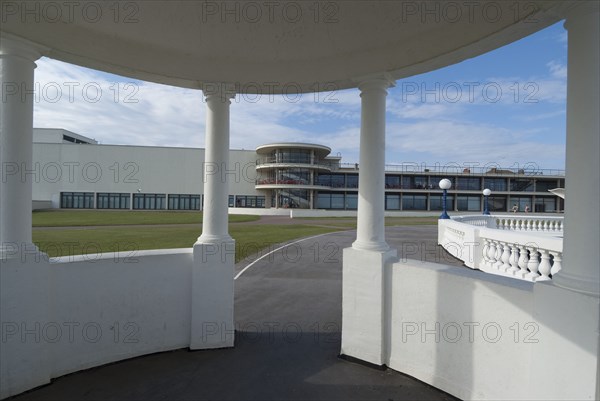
[0,36,53,399]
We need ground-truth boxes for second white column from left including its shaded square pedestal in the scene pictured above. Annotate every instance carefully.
[190,84,235,349]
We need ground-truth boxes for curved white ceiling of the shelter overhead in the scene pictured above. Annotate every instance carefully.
[0,0,573,93]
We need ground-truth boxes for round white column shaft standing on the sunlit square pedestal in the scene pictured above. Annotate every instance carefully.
[352,76,394,251]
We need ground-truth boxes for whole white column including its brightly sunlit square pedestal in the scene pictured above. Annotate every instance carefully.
[341,75,397,365]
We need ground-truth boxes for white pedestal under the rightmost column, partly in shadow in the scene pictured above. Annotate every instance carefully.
[532,280,600,400]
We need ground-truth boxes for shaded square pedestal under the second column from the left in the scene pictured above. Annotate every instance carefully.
[190,237,235,350]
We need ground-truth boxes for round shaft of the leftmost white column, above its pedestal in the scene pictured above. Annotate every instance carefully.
[0,34,41,258]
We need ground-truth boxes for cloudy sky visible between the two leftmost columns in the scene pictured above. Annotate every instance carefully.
[34,59,204,146]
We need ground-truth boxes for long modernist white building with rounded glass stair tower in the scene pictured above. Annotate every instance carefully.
[32,129,564,213]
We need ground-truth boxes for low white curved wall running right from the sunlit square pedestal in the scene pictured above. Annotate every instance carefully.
[383,260,600,400]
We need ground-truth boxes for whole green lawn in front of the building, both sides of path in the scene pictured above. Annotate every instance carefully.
[33,210,437,262]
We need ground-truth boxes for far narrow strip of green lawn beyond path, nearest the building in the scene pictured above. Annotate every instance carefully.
[33,210,259,227]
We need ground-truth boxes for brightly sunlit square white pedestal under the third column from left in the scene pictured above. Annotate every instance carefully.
[341,247,397,366]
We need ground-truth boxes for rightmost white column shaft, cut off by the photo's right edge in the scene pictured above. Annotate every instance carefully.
[553,2,600,296]
